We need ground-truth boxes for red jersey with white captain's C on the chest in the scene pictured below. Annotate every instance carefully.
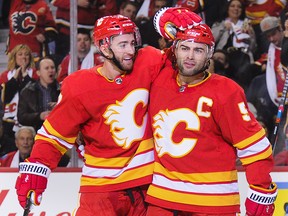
[146,67,273,214]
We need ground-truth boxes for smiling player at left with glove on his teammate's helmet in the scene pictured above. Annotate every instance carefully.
[16,8,201,216]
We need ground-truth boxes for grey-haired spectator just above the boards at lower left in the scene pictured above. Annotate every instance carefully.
[0,126,36,168]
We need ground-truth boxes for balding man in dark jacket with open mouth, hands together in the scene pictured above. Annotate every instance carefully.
[17,57,60,131]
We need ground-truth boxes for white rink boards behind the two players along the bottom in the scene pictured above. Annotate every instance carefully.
[0,167,288,216]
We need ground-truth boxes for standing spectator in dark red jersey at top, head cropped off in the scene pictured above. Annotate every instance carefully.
[51,0,117,61]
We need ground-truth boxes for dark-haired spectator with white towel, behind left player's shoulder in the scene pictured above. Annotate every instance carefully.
[57,28,104,83]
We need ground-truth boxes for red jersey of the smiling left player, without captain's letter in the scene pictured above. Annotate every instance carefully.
[30,47,164,192]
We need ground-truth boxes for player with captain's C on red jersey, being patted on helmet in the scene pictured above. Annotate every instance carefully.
[146,23,277,216]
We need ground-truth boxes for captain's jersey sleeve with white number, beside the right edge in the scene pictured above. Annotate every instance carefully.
[216,82,273,188]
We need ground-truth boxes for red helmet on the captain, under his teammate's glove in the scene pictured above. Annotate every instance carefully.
[176,24,215,51]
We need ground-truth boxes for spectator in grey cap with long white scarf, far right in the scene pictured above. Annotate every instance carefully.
[247,16,286,154]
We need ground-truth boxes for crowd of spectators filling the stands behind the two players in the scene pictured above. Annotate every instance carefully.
[0,0,288,166]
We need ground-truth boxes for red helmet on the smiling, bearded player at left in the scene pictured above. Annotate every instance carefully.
[93,15,141,48]
